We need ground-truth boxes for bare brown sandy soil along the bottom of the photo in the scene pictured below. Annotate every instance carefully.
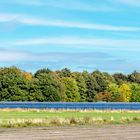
[0,124,140,140]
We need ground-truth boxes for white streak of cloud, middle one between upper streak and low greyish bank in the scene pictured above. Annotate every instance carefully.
[1,37,140,51]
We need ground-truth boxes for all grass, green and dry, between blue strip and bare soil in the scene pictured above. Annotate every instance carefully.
[0,109,140,127]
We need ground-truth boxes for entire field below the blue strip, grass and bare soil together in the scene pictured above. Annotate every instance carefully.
[0,109,140,140]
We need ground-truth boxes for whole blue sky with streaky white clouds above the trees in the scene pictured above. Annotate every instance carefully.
[0,0,140,73]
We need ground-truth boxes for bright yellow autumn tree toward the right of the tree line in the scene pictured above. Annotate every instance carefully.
[119,83,132,102]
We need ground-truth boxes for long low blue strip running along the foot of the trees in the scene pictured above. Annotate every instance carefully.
[0,102,140,110]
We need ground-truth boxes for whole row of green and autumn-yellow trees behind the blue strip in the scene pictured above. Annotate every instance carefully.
[0,67,140,102]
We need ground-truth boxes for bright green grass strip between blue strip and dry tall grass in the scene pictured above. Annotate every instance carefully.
[0,110,140,120]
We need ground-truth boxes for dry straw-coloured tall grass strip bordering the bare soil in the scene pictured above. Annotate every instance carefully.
[0,116,140,127]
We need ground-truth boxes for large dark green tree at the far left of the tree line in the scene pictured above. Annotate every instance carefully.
[0,67,28,101]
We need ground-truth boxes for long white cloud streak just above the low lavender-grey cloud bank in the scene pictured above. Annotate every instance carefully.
[13,37,140,50]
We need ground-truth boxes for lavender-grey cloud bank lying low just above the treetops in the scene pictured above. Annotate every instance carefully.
[0,50,140,72]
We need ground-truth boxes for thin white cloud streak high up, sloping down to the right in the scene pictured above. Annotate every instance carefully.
[0,14,140,31]
